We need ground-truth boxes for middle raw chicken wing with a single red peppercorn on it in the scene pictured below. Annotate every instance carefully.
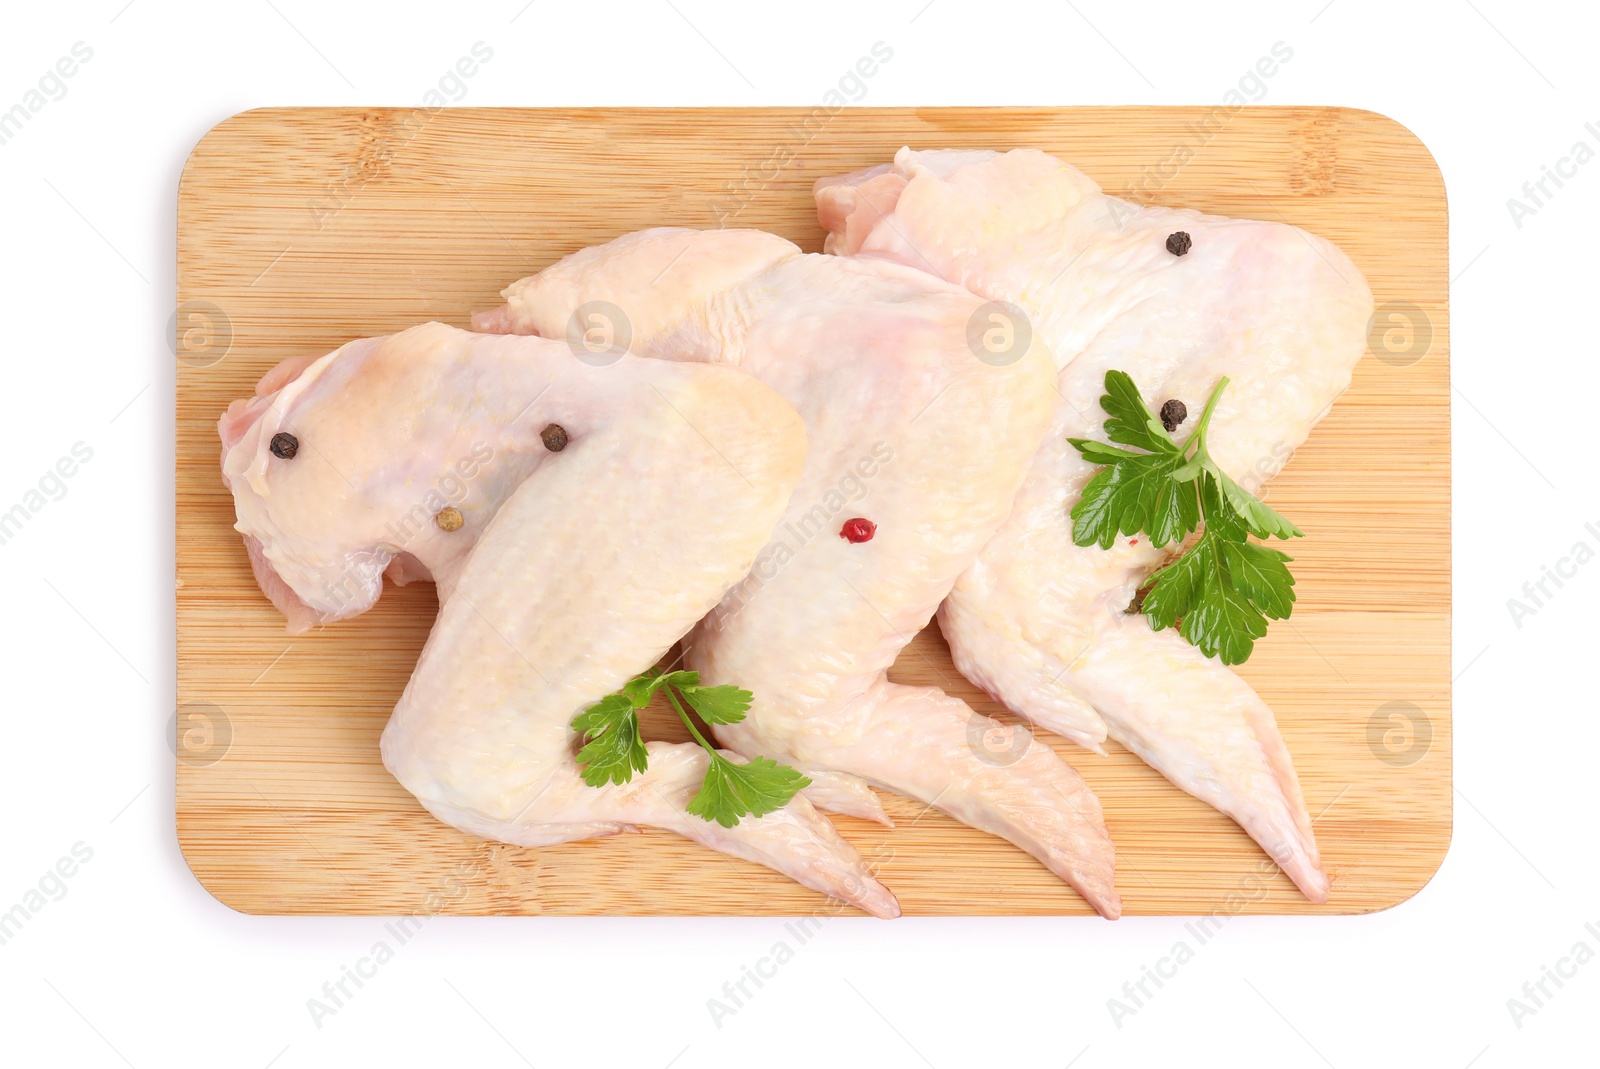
[474,229,1120,917]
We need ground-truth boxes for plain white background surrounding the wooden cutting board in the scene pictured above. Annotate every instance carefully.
[0,0,1600,1069]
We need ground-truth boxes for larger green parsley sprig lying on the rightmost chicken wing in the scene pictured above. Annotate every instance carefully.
[1069,371,1304,664]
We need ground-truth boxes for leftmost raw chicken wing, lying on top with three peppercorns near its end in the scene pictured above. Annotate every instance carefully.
[219,323,899,917]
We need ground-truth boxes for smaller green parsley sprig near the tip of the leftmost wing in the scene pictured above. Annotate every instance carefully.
[573,669,811,827]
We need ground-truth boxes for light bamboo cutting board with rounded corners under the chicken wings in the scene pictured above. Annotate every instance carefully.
[174,107,1451,915]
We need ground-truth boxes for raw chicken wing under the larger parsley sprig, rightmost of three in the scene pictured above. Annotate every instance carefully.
[816,149,1373,901]
